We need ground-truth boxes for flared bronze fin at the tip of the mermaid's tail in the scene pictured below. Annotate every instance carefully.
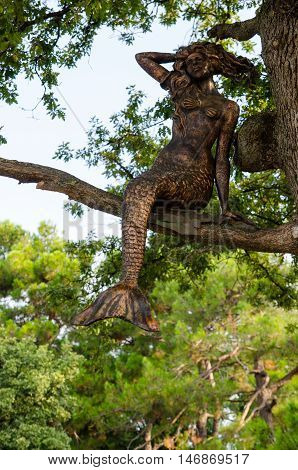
[72,284,159,332]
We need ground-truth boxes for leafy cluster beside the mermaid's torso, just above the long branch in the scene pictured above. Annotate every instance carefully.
[55,86,173,187]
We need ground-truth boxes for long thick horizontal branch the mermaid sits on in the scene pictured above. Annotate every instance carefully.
[0,158,298,254]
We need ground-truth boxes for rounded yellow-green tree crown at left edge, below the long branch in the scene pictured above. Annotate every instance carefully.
[0,219,84,324]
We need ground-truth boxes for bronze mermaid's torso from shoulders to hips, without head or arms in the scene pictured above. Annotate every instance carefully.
[148,78,227,207]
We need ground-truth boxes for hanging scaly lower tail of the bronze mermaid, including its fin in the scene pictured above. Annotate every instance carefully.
[73,176,159,331]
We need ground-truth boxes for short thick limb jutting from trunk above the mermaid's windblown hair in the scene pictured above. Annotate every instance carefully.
[208,16,259,41]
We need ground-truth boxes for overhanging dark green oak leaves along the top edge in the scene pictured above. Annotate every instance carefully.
[0,0,256,118]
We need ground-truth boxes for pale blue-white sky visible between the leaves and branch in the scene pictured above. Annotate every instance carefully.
[0,9,258,240]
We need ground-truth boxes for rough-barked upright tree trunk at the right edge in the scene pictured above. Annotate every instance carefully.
[259,0,298,207]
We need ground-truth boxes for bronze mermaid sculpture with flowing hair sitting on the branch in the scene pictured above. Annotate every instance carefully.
[73,42,254,331]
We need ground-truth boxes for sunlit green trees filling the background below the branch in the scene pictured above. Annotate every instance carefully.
[0,222,298,449]
